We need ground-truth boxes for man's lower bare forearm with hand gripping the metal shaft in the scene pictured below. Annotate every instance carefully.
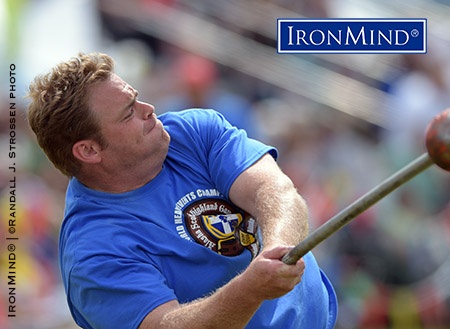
[139,247,305,329]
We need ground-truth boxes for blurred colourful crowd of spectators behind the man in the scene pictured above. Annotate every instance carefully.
[0,0,450,329]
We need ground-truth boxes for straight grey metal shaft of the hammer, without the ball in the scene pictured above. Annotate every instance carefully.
[282,153,434,265]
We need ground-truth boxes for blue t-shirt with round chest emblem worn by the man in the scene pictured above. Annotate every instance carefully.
[60,109,337,329]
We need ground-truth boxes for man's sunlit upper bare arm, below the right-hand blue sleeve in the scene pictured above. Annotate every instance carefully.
[229,154,308,248]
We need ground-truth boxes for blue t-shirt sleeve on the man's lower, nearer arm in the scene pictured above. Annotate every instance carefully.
[68,245,176,329]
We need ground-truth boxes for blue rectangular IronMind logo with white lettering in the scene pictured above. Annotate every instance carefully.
[277,18,427,54]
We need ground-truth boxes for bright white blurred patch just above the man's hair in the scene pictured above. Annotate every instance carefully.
[17,0,101,87]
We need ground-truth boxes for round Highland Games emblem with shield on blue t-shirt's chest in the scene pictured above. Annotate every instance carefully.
[175,193,259,257]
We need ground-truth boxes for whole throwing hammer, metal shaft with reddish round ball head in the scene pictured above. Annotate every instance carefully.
[282,108,450,264]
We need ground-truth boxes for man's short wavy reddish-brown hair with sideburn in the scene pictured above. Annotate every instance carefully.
[27,53,114,177]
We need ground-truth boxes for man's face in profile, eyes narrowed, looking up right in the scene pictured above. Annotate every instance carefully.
[89,74,170,169]
